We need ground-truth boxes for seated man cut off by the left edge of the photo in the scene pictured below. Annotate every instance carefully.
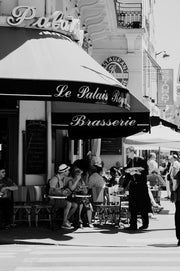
[0,165,17,228]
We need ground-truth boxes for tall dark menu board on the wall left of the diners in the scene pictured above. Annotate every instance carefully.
[25,120,47,174]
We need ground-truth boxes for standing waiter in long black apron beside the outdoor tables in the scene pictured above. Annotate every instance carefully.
[123,146,151,230]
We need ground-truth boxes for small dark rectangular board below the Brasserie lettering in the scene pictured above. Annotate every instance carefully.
[101,137,122,154]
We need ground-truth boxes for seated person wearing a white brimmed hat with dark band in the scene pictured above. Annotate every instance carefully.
[49,164,78,229]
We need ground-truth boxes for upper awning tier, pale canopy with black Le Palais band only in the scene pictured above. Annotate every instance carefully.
[0,27,129,107]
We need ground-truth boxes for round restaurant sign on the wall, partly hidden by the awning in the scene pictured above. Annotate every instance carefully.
[102,56,129,86]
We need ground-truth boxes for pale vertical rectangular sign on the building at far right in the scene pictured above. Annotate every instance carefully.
[158,69,174,106]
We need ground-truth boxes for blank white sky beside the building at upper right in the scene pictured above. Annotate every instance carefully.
[155,0,180,88]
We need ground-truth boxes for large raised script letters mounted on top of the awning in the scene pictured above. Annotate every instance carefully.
[7,6,81,39]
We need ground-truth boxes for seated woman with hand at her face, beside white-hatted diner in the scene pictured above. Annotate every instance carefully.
[69,166,93,228]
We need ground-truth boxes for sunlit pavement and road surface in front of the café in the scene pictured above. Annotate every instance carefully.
[0,196,180,271]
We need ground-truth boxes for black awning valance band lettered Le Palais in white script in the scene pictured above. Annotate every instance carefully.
[0,78,130,110]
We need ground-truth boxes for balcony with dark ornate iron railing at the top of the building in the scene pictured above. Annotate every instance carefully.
[114,0,142,28]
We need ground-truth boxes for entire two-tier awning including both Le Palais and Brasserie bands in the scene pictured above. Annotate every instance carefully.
[0,27,150,138]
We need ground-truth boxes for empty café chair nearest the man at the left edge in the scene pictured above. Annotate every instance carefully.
[12,186,32,227]
